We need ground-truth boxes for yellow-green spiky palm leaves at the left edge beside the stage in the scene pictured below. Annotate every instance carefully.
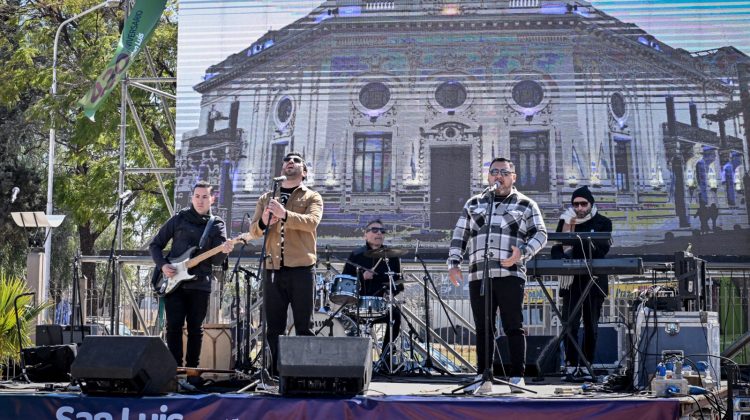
[0,270,50,361]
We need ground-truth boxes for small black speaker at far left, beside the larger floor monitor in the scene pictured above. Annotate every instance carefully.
[22,344,76,382]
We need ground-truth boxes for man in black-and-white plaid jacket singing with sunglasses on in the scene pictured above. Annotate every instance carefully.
[448,158,547,377]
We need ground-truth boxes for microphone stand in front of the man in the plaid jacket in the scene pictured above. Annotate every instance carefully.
[451,187,537,394]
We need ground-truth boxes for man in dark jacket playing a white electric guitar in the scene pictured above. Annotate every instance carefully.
[148,181,234,367]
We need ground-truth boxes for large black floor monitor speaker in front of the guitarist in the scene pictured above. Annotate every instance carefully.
[71,335,177,395]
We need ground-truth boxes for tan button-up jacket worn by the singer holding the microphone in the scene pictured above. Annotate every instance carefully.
[250,184,323,270]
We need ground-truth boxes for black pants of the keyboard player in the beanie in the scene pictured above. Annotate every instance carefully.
[560,276,607,366]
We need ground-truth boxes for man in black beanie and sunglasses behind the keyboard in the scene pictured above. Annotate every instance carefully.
[552,186,612,381]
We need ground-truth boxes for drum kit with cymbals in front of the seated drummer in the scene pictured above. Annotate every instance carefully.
[302,247,414,374]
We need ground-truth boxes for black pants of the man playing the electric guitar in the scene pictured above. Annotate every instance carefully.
[164,287,211,367]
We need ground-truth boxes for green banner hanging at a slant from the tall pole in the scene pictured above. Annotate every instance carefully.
[78,0,167,121]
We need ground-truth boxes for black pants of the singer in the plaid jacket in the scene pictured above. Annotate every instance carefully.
[469,276,526,376]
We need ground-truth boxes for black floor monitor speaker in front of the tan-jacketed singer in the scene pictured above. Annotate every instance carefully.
[278,336,372,395]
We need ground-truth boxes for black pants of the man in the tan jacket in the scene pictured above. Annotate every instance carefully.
[263,266,315,376]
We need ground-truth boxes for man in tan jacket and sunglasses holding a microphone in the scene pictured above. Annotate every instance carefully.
[250,152,323,376]
